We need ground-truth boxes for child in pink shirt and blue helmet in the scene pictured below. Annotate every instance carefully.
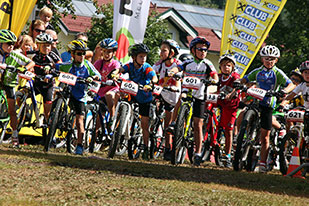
[94,38,120,123]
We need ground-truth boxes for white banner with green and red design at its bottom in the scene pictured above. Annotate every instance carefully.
[113,0,150,63]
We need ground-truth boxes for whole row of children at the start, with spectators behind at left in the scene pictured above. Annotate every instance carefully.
[0,5,309,172]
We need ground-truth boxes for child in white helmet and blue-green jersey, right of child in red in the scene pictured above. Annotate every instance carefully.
[235,45,295,173]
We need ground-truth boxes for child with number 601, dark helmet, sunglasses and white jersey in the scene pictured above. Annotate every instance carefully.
[168,36,219,166]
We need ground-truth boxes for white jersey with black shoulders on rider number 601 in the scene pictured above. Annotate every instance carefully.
[178,59,217,100]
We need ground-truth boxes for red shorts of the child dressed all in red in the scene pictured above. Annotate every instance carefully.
[219,107,237,130]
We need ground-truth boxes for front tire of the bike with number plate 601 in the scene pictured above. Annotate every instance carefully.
[171,104,190,165]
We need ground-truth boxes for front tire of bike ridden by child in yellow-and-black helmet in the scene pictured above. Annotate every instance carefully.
[44,98,63,152]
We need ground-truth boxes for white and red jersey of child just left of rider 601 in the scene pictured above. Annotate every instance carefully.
[153,59,181,106]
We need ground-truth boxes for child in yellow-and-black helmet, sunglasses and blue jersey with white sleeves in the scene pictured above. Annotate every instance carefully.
[56,40,101,155]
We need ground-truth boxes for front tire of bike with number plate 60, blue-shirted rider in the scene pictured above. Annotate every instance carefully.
[108,104,129,158]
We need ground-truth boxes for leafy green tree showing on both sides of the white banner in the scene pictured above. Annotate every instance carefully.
[87,1,171,65]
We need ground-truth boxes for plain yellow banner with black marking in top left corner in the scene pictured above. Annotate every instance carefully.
[0,0,36,37]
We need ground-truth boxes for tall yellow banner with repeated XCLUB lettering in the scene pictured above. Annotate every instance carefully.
[220,0,286,77]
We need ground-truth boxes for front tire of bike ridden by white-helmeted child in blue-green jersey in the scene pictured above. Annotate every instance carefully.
[233,110,255,171]
